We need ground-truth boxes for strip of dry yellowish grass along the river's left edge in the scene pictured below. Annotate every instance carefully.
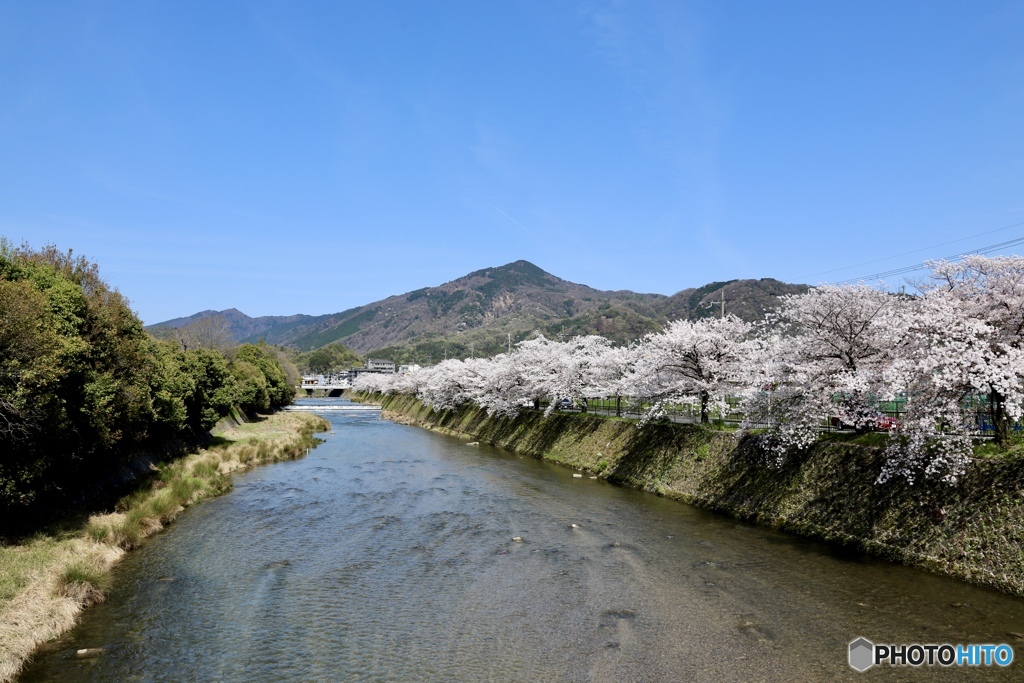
[0,413,327,683]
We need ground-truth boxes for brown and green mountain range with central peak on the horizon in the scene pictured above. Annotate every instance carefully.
[151,261,807,362]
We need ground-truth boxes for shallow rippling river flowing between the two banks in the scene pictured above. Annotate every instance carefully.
[19,401,1024,683]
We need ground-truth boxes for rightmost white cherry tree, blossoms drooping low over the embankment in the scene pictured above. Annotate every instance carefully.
[879,256,1024,483]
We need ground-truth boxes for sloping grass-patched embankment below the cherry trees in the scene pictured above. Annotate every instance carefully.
[366,395,1024,596]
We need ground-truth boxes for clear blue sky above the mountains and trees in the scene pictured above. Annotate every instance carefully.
[0,0,1024,323]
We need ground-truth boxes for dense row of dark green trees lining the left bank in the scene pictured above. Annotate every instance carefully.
[0,239,297,535]
